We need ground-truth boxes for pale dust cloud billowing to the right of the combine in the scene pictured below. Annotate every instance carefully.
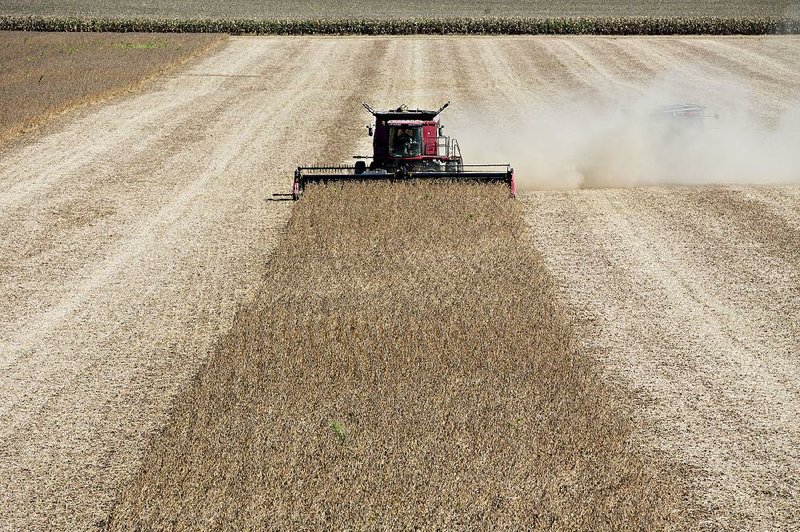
[453,77,800,190]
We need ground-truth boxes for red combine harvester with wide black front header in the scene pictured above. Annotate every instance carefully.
[292,102,516,200]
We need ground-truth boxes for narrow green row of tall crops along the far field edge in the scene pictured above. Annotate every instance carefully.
[0,16,800,35]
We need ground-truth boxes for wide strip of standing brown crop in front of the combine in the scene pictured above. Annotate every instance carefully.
[110,184,686,529]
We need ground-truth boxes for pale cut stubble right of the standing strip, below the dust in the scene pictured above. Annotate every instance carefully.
[522,186,800,530]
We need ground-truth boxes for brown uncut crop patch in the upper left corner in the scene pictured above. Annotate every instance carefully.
[0,32,224,139]
